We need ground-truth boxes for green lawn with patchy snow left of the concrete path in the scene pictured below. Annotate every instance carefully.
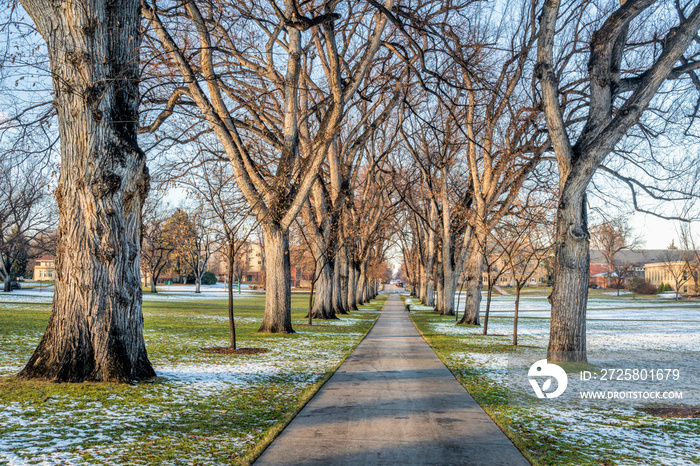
[0,294,386,465]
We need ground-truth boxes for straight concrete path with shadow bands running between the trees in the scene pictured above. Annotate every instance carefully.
[255,295,529,466]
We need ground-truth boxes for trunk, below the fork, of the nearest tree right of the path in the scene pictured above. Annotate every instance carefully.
[547,190,590,362]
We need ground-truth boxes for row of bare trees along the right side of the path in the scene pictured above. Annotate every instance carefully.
[394,0,700,361]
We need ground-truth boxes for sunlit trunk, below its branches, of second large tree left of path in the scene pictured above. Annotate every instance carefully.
[258,223,294,333]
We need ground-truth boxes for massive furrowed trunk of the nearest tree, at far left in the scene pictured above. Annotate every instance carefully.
[20,0,155,382]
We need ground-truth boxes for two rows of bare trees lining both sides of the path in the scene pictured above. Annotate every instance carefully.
[4,0,700,381]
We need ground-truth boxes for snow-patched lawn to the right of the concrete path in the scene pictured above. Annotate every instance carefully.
[411,295,700,465]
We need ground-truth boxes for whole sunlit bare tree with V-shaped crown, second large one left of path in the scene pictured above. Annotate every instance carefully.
[142,0,394,333]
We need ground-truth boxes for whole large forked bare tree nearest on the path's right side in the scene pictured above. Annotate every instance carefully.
[535,0,700,361]
